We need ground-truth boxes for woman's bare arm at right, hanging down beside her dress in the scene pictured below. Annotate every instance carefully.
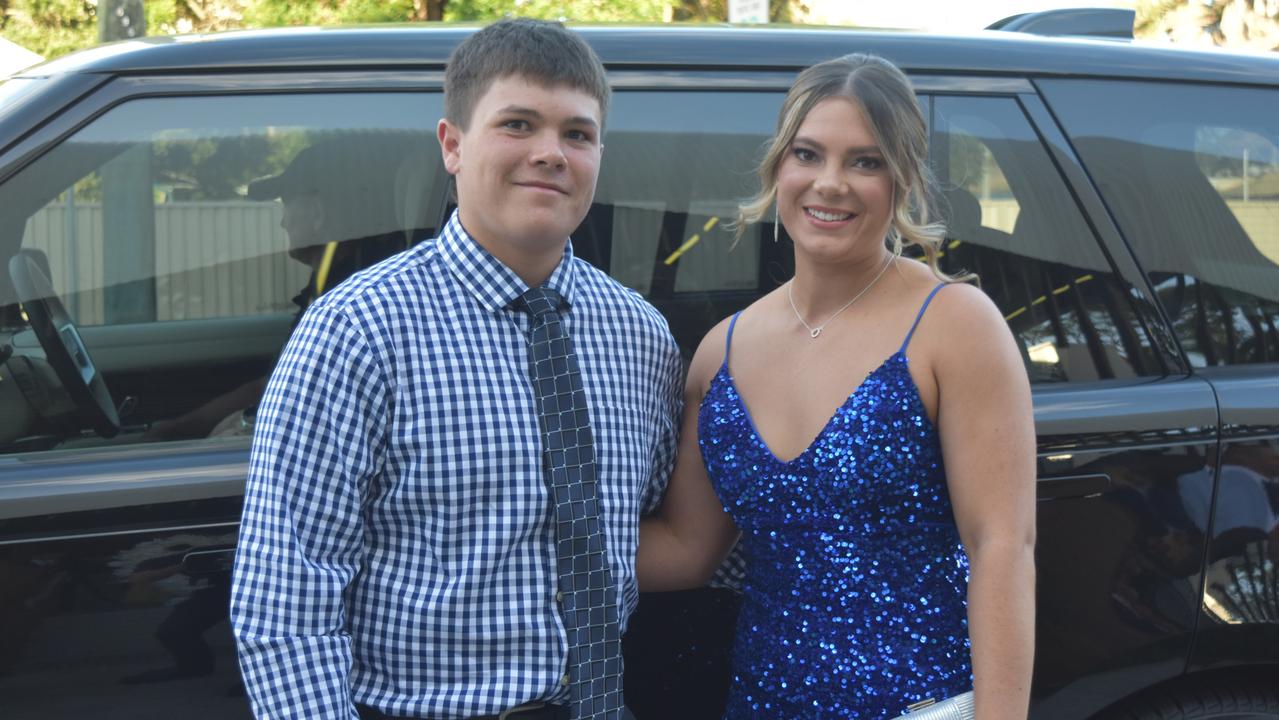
[930,285,1035,720]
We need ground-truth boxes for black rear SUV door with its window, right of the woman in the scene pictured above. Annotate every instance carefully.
[917,78,1218,719]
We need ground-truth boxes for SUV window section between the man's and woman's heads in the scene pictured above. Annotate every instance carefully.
[595,92,781,299]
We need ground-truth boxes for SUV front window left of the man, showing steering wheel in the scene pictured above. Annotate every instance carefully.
[0,93,444,450]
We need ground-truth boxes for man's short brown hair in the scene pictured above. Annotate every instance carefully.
[444,18,611,130]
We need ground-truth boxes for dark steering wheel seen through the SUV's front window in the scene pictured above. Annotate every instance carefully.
[9,252,120,437]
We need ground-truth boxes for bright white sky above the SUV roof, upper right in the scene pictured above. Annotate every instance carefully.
[806,0,1136,32]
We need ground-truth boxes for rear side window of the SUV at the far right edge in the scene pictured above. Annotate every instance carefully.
[1044,81,1279,367]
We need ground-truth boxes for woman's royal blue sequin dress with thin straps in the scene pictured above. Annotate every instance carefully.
[697,285,972,720]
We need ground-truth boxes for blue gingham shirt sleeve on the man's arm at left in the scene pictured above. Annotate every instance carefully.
[230,306,388,720]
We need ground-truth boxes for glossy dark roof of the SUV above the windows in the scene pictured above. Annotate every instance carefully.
[15,24,1279,84]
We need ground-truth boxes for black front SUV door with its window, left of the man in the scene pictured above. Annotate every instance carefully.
[0,72,445,719]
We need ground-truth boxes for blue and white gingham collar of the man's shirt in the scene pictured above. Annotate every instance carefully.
[439,211,577,318]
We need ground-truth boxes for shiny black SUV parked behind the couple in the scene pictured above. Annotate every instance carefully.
[0,16,1279,720]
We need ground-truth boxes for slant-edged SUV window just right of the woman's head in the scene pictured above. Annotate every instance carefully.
[932,96,1159,382]
